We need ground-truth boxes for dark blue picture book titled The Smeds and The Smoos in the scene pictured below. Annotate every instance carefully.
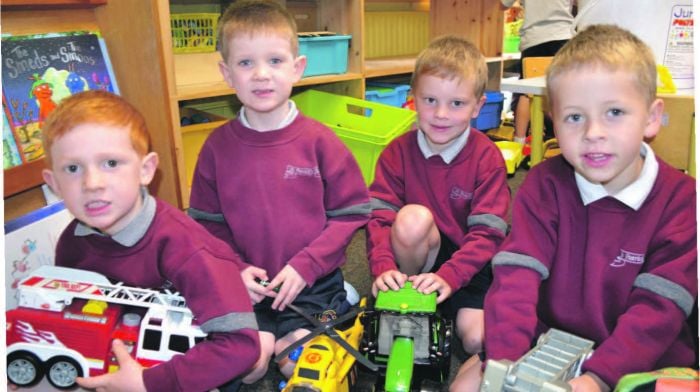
[1,32,119,164]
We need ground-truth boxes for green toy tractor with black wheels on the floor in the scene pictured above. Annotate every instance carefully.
[360,282,452,392]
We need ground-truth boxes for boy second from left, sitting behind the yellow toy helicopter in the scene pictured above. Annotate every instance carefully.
[189,1,369,383]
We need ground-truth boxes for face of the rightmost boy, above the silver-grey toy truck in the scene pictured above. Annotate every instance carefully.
[550,67,663,194]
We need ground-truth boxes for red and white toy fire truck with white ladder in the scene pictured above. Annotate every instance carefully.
[6,266,206,389]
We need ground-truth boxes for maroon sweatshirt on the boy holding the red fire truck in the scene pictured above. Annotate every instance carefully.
[56,196,260,391]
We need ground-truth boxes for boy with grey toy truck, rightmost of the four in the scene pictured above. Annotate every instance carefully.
[476,25,698,391]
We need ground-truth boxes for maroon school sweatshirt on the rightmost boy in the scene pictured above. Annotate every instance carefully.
[484,154,698,387]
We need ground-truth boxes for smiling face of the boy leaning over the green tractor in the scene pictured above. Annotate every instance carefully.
[414,74,484,152]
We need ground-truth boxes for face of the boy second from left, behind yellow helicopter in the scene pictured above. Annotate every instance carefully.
[219,32,306,124]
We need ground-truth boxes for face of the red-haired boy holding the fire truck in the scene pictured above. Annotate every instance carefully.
[43,123,158,235]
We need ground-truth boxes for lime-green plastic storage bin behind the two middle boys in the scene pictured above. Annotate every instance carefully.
[292,90,416,185]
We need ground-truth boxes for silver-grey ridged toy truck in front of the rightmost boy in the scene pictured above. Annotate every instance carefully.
[480,328,593,392]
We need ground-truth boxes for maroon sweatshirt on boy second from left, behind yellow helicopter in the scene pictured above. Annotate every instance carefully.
[188,114,369,286]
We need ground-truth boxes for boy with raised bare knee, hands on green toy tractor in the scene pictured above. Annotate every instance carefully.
[367,36,510,388]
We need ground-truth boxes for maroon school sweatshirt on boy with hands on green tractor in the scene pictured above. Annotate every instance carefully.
[367,130,510,292]
